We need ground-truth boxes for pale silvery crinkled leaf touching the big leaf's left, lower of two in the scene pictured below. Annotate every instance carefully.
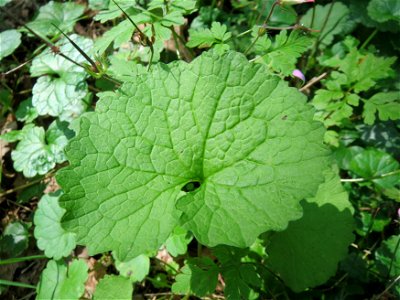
[11,121,72,177]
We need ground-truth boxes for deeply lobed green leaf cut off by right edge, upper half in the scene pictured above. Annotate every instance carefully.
[362,92,400,125]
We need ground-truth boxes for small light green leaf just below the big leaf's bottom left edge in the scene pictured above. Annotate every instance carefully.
[114,254,150,282]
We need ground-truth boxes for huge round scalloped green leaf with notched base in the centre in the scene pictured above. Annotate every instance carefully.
[57,52,328,259]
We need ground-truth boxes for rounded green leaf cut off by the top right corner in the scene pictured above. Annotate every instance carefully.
[367,0,400,25]
